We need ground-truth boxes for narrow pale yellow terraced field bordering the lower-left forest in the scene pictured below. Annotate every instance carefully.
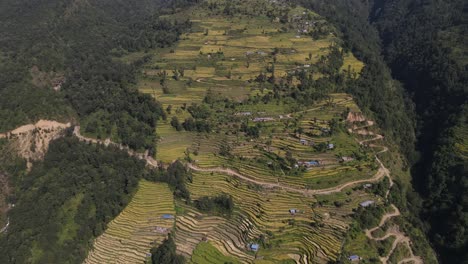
[85,180,175,263]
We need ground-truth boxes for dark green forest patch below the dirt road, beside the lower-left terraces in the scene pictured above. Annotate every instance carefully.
[0,137,145,263]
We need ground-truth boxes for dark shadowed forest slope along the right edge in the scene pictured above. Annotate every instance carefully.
[372,0,468,263]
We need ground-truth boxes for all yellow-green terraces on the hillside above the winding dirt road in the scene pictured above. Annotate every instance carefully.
[132,1,377,218]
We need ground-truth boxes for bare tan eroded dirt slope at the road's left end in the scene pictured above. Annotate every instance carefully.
[0,120,71,169]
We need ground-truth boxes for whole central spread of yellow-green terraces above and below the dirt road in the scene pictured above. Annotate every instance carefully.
[117,0,388,263]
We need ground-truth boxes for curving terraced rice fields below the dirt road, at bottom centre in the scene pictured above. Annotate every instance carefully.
[176,170,347,263]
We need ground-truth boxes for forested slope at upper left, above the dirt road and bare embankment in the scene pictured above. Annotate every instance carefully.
[0,0,194,153]
